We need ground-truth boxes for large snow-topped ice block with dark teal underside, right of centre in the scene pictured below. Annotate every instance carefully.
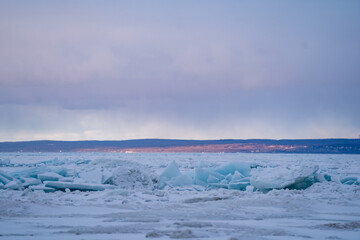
[250,165,319,190]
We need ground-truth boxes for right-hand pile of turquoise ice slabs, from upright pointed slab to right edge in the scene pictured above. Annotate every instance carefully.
[157,162,360,191]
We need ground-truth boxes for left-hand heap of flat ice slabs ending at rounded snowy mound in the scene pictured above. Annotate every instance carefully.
[0,159,156,192]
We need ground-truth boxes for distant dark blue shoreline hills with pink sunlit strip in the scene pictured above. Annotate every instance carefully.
[0,138,360,154]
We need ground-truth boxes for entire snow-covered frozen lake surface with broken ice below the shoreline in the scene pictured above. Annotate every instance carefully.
[0,153,360,240]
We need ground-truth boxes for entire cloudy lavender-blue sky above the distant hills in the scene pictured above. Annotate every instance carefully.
[0,0,360,141]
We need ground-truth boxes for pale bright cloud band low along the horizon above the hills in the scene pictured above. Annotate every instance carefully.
[0,102,358,141]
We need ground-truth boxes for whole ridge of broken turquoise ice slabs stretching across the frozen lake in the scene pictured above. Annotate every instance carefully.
[0,158,359,192]
